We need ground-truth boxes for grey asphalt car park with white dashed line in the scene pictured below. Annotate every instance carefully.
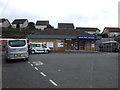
[2,52,118,88]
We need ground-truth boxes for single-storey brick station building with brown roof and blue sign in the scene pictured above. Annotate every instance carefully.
[26,28,100,51]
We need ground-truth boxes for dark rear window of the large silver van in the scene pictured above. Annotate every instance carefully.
[8,40,26,47]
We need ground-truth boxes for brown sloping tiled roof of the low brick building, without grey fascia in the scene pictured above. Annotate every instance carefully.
[36,29,93,36]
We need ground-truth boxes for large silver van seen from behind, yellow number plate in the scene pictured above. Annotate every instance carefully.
[6,39,29,60]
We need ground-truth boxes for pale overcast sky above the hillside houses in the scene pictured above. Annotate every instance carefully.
[0,0,119,30]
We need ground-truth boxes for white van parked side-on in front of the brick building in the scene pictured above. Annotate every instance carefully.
[30,42,50,53]
